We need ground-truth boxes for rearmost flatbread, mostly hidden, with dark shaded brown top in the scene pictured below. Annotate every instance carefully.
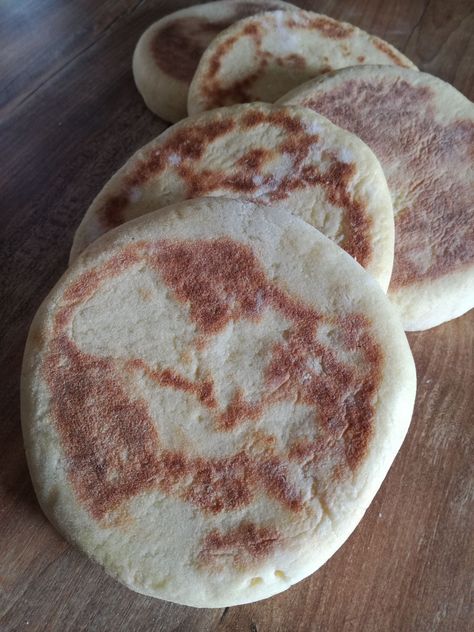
[133,0,293,122]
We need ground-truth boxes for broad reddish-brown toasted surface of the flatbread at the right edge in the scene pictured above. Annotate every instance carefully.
[305,77,474,289]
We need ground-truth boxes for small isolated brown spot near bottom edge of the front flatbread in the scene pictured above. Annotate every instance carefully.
[197,522,279,569]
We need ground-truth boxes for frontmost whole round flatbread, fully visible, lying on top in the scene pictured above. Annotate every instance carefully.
[22,198,415,607]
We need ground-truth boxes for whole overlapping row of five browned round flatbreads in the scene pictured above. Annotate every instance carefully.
[22,0,474,607]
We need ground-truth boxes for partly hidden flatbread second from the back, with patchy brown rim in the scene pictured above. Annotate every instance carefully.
[188,10,416,114]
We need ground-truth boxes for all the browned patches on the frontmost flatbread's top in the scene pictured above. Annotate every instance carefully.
[43,238,382,565]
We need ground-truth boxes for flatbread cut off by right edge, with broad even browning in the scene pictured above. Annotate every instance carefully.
[282,66,474,331]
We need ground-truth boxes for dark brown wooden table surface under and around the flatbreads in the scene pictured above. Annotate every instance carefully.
[0,0,474,632]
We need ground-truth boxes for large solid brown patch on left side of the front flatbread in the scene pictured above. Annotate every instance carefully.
[45,333,163,519]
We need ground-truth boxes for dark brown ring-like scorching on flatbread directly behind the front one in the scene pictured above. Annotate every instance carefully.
[98,109,373,266]
